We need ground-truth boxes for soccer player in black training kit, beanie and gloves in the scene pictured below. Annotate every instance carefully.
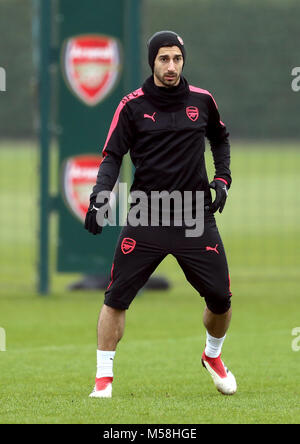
[85,31,237,398]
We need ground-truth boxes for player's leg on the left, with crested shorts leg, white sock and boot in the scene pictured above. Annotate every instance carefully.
[90,226,167,398]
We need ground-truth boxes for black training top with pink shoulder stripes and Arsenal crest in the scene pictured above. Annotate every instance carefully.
[91,77,231,209]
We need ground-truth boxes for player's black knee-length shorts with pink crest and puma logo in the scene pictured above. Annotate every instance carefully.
[104,218,231,314]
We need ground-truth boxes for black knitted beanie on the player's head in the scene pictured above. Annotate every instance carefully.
[148,31,185,72]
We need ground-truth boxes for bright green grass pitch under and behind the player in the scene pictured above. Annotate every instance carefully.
[0,142,300,424]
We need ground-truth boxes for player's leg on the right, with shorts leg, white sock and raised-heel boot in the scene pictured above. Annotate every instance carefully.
[175,220,236,395]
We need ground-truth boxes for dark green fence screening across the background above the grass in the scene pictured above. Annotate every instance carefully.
[0,0,300,140]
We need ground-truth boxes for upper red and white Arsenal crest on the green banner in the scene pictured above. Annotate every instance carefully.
[63,34,121,106]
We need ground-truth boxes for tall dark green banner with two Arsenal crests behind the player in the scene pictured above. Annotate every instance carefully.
[54,0,138,276]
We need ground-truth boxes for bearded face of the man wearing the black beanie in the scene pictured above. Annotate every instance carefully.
[153,46,183,88]
